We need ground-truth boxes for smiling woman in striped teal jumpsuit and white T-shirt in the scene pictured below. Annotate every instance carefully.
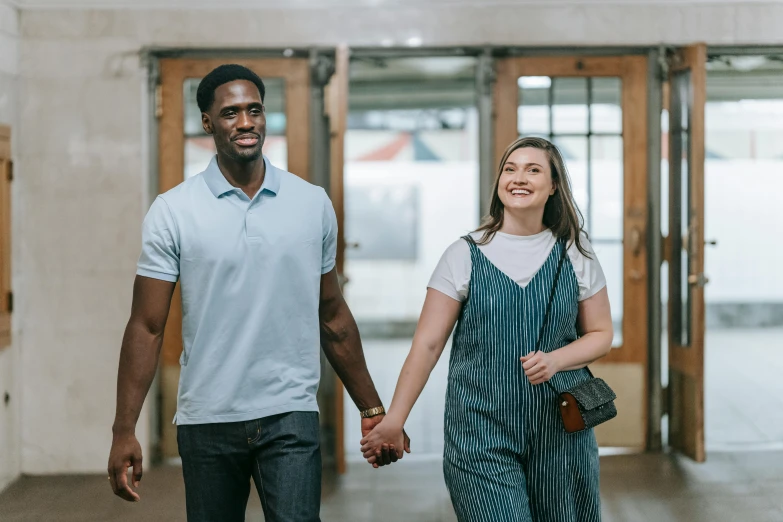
[362,138,612,522]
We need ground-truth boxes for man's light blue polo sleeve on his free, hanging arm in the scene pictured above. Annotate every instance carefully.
[136,196,180,283]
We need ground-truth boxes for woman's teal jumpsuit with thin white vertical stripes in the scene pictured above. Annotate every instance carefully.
[443,241,601,522]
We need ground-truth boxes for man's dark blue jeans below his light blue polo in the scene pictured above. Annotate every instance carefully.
[177,411,321,522]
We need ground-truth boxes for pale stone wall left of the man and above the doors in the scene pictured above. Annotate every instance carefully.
[13,2,783,473]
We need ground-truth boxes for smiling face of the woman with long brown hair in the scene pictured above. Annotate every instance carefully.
[498,147,556,212]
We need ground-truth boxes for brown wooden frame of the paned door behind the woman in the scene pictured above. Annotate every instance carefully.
[493,55,658,448]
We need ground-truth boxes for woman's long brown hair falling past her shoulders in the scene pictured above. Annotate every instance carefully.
[476,138,590,257]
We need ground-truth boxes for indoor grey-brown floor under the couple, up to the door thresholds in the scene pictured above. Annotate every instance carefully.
[0,452,783,522]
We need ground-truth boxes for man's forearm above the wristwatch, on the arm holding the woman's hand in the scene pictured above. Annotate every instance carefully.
[321,303,381,410]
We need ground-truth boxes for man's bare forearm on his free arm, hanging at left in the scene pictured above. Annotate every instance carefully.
[112,322,163,434]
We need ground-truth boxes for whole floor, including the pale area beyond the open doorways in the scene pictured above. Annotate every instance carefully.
[0,324,783,522]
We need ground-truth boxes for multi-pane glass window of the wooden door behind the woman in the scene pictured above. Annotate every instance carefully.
[517,76,625,346]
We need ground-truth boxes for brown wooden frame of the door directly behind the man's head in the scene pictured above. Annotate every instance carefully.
[156,57,311,458]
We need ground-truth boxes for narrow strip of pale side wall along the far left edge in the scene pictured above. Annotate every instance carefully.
[0,0,21,490]
